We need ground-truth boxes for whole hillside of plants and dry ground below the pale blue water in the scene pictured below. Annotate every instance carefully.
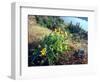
[28,16,88,66]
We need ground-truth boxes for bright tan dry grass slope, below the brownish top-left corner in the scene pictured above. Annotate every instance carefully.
[28,25,51,43]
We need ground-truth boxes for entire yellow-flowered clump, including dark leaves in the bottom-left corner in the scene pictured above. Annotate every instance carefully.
[30,28,71,66]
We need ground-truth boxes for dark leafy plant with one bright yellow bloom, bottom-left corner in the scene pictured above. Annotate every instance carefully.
[30,47,48,66]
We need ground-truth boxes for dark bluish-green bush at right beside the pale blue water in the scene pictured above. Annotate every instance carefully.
[65,22,88,40]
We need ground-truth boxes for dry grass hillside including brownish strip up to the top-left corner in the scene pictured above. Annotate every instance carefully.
[28,16,51,43]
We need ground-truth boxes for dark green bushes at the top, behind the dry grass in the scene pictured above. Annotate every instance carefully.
[35,16,64,29]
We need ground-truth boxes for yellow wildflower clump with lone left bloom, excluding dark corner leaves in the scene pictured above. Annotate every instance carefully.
[30,28,68,65]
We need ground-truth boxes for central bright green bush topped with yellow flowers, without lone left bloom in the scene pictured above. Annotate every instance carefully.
[41,28,69,65]
